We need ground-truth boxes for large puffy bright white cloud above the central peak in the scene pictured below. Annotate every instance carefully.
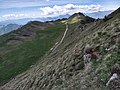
[40,4,101,16]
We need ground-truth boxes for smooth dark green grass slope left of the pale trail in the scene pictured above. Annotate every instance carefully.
[0,24,65,85]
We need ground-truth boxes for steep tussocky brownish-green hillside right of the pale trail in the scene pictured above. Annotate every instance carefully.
[1,7,120,90]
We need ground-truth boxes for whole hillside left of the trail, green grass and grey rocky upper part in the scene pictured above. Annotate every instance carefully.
[0,21,65,85]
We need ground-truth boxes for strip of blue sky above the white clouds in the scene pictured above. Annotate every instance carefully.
[0,0,120,8]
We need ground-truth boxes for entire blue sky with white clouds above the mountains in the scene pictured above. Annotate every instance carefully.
[0,0,120,21]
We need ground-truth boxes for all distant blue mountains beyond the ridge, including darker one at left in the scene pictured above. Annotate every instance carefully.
[0,10,112,35]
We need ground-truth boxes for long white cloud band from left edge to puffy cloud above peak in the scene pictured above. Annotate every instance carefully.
[0,3,101,21]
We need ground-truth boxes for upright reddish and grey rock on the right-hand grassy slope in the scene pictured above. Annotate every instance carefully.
[83,44,93,67]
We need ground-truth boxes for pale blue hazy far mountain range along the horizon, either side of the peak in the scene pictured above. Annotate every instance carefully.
[0,10,112,25]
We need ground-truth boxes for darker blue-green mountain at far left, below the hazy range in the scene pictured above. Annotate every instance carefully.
[0,24,21,35]
